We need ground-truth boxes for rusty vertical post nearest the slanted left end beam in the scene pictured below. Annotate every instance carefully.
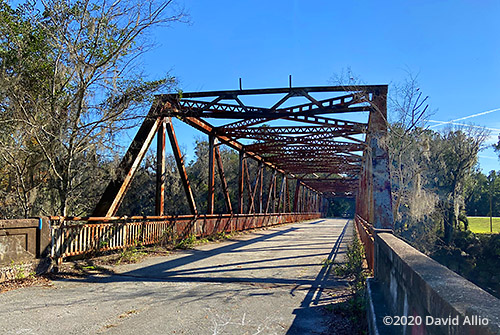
[155,118,167,216]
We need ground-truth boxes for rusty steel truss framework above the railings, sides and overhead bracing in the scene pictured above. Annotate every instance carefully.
[93,85,392,234]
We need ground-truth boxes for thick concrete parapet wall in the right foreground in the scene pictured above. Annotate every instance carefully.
[374,233,500,334]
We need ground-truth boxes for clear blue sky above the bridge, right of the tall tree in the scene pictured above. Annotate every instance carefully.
[137,0,500,172]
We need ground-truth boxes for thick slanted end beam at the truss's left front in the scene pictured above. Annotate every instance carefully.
[92,113,160,217]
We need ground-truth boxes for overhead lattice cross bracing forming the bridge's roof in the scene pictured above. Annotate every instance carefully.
[161,86,386,197]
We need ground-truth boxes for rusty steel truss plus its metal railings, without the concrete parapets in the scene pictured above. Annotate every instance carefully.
[51,85,393,265]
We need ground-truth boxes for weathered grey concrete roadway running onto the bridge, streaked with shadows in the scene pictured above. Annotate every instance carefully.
[0,219,352,334]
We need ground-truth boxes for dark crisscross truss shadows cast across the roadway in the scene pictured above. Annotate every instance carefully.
[54,220,350,334]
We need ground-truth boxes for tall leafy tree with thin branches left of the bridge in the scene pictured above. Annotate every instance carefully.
[0,0,185,215]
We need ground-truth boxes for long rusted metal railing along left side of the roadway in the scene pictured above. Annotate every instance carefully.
[51,213,320,260]
